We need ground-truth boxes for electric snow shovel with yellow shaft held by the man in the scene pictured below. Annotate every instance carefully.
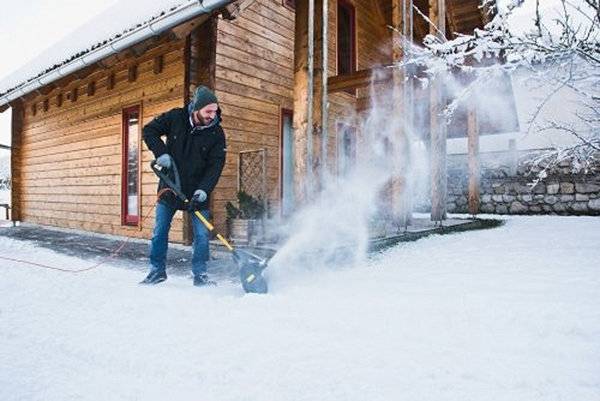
[150,159,268,294]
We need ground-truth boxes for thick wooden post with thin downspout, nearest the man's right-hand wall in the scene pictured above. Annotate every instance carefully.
[294,0,323,204]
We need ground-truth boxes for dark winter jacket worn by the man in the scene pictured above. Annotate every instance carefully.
[143,108,227,210]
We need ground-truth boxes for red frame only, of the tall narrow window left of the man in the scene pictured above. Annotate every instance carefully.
[121,105,142,226]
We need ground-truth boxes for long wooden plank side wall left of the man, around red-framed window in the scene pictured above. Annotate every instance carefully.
[14,37,184,242]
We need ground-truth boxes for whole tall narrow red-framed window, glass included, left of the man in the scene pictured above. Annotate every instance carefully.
[121,106,140,225]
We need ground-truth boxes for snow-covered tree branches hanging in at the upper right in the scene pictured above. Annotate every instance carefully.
[402,0,600,178]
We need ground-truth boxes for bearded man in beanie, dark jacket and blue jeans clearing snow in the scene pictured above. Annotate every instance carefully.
[141,86,226,286]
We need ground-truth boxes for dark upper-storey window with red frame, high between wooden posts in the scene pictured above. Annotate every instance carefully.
[337,0,356,75]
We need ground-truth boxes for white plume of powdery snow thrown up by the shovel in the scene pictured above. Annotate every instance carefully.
[266,79,428,290]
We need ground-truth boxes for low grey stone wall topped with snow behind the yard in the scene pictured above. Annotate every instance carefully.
[447,153,600,215]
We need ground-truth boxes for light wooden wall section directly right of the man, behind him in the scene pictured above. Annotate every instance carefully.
[213,0,294,231]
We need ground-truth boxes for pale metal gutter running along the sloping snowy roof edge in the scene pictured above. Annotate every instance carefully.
[0,0,231,106]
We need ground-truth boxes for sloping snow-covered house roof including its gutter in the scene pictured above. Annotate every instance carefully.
[0,0,232,107]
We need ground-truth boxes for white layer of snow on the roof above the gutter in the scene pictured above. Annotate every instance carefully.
[0,0,198,96]
